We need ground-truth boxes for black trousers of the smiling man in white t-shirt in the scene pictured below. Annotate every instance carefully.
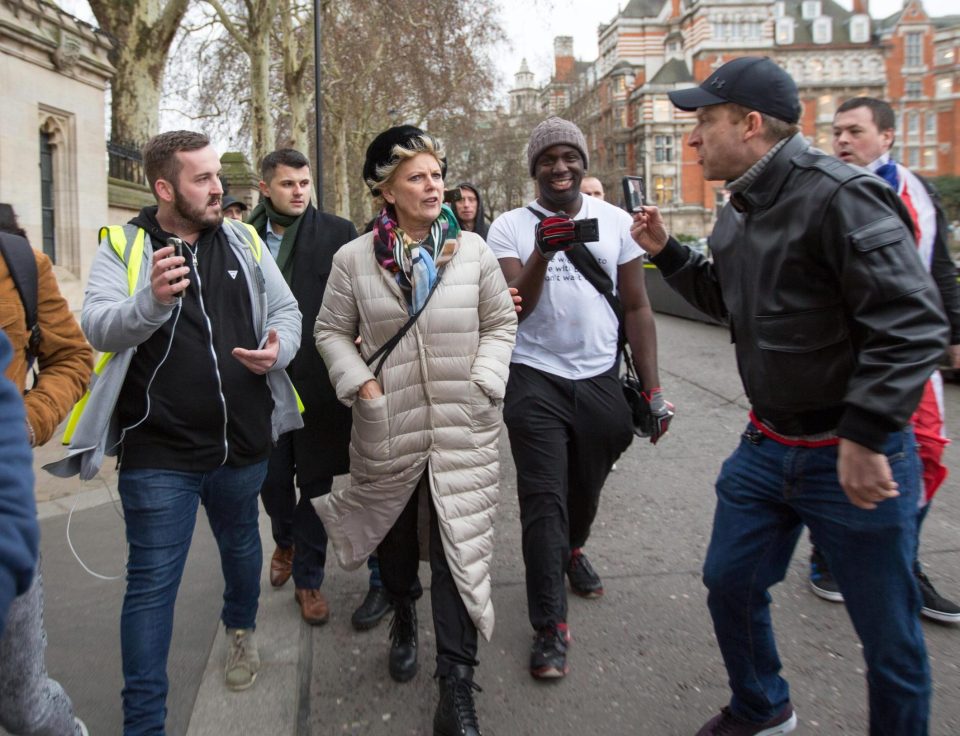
[503,363,633,629]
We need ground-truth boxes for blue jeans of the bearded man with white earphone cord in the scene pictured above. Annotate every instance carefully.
[119,460,267,734]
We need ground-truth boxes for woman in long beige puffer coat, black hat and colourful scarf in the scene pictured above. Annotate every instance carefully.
[313,126,517,734]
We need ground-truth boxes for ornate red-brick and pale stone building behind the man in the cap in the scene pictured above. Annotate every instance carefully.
[511,0,960,236]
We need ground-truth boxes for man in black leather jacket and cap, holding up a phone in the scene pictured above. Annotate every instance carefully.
[633,57,947,736]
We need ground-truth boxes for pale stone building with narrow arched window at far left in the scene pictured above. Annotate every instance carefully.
[0,0,113,308]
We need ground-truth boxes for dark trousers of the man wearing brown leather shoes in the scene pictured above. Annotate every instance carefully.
[260,432,333,588]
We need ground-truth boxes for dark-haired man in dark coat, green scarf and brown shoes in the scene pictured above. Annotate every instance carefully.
[249,148,388,628]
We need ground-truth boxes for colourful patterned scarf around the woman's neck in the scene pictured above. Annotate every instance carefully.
[373,204,460,314]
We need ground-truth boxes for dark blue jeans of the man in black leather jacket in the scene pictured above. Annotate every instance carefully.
[703,426,930,736]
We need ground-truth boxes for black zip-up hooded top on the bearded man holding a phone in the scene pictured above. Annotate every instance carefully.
[117,206,273,472]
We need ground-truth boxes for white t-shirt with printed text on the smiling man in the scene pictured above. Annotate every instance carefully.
[487,197,643,379]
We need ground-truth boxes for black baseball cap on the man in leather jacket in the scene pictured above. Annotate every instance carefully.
[668,56,800,123]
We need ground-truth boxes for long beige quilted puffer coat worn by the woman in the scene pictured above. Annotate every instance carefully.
[313,232,517,639]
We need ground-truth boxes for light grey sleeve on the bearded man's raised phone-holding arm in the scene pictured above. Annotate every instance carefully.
[80,238,176,353]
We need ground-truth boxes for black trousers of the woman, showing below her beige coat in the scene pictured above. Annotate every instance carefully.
[377,476,479,677]
